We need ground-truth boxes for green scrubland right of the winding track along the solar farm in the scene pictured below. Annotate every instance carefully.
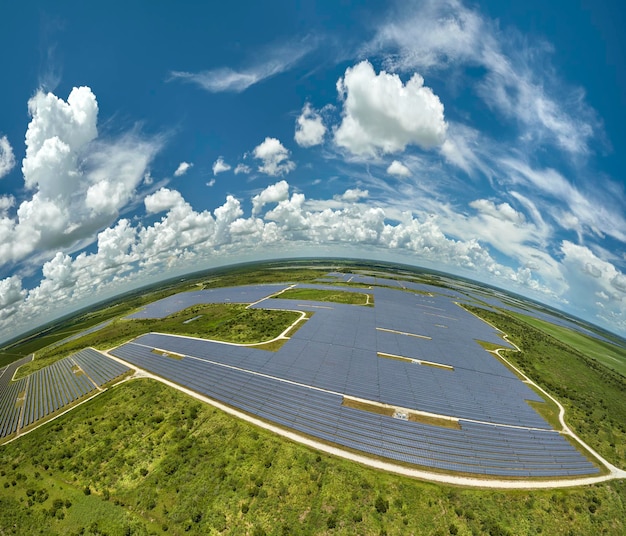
[466,306,626,467]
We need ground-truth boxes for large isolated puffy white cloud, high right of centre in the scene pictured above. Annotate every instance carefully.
[335,61,447,156]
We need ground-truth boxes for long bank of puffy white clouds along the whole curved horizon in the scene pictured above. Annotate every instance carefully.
[8,180,626,337]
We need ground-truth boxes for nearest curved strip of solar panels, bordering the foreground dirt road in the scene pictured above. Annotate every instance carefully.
[114,341,597,477]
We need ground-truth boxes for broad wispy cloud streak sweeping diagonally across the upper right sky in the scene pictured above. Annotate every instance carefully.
[366,0,599,153]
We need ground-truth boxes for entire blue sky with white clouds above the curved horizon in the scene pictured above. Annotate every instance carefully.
[0,0,626,340]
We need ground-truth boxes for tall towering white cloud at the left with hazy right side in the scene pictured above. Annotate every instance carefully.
[0,87,160,263]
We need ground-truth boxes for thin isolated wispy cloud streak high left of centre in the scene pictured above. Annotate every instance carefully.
[170,40,314,93]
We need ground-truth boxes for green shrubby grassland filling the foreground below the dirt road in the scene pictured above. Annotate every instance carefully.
[0,379,626,535]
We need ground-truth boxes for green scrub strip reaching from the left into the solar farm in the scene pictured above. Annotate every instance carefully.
[16,303,300,378]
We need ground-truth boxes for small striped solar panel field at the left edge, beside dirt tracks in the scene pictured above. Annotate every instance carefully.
[0,348,130,438]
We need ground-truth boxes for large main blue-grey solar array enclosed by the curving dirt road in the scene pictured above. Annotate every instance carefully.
[113,280,598,477]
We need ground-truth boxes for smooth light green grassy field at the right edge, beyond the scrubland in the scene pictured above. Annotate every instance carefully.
[510,313,626,377]
